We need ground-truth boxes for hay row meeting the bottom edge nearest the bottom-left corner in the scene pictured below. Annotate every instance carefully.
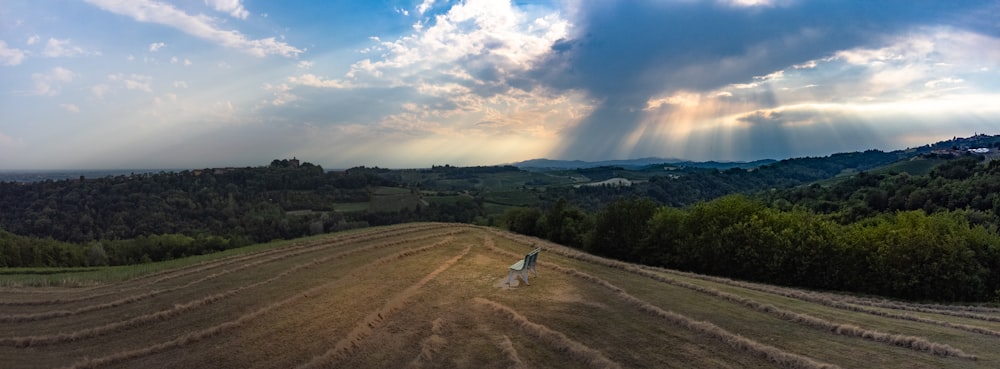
[58,233,454,369]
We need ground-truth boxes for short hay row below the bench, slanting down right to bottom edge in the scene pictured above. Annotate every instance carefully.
[472,297,621,368]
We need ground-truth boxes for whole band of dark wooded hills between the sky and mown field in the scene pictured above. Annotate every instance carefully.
[0,135,1000,301]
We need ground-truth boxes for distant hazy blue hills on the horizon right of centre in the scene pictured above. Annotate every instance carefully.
[511,157,776,171]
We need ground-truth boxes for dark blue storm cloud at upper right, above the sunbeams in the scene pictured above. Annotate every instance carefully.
[534,1,997,159]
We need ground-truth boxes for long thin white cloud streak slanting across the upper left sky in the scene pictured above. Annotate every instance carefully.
[86,0,304,57]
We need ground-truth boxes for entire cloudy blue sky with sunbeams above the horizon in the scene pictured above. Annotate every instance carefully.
[0,0,1000,170]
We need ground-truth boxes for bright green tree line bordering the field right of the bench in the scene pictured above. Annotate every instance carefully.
[503,195,1000,301]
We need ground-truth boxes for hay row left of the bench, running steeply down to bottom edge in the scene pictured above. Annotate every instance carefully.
[298,245,472,369]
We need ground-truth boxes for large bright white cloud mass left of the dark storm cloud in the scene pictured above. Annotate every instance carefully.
[274,0,595,160]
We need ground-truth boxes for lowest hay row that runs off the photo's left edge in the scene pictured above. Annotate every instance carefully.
[0,233,458,347]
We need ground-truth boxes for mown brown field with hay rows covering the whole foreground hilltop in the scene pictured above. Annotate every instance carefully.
[0,223,1000,368]
